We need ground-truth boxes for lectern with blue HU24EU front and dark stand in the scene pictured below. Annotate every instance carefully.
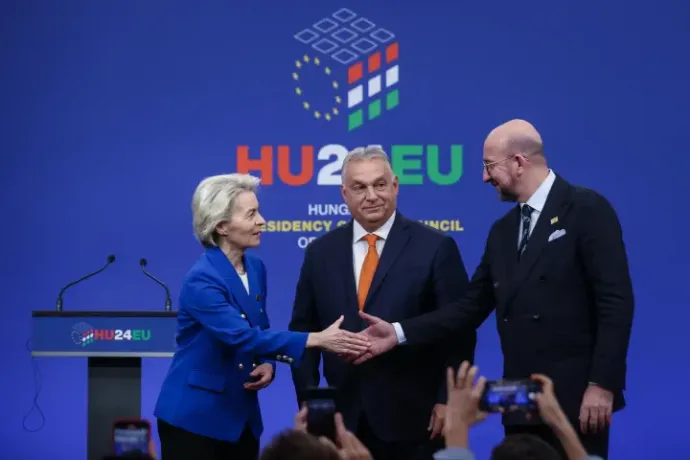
[31,311,177,460]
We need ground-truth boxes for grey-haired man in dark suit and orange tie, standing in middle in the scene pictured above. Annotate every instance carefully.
[289,147,476,460]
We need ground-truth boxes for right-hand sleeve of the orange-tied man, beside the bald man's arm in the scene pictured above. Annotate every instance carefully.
[433,237,477,404]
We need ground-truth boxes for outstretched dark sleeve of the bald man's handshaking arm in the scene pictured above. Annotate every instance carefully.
[400,231,495,346]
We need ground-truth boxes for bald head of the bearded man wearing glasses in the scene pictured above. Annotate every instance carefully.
[482,120,548,202]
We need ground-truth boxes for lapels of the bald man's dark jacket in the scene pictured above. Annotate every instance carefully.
[506,176,571,301]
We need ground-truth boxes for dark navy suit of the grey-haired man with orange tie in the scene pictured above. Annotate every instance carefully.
[289,211,476,442]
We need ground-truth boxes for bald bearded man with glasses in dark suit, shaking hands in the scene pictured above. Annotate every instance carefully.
[357,120,634,458]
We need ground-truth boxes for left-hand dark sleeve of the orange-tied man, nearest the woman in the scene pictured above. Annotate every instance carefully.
[288,246,321,406]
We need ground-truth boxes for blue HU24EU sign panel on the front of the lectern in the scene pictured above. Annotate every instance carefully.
[31,311,177,358]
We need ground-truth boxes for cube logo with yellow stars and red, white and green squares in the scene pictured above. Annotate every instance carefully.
[292,8,400,131]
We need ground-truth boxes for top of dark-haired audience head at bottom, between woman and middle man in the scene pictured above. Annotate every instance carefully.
[260,430,340,460]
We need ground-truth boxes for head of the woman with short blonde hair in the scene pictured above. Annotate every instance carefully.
[192,174,266,250]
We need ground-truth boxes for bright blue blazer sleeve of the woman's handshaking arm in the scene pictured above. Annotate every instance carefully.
[180,273,308,366]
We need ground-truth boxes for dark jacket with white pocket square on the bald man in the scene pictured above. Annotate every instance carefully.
[400,175,634,426]
